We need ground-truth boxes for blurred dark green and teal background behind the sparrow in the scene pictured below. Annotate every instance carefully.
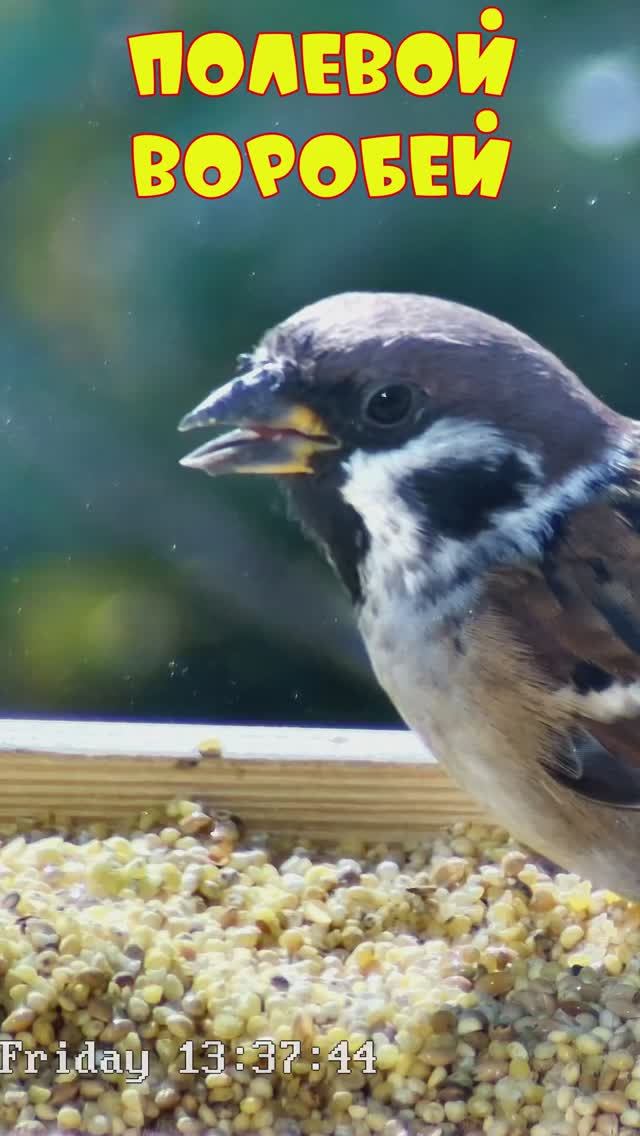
[0,0,640,724]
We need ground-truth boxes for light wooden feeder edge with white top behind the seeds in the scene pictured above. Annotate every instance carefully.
[0,719,481,840]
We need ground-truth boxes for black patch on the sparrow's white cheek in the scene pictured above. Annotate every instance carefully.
[399,453,533,541]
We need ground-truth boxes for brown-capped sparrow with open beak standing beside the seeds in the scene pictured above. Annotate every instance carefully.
[180,292,640,902]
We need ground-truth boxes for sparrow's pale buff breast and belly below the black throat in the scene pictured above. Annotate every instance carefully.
[360,595,640,895]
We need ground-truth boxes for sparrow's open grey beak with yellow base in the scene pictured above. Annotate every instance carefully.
[178,369,338,477]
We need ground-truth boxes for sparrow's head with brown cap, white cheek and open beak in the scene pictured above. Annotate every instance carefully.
[181,293,620,601]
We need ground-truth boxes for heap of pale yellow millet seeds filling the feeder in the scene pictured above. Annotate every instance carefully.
[0,802,640,1136]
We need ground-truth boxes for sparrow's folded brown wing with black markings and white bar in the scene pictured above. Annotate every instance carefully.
[490,479,640,808]
